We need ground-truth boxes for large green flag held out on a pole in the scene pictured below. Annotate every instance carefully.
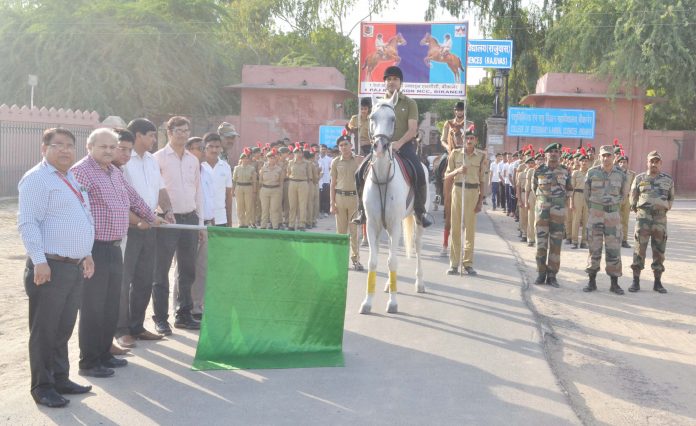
[193,227,348,370]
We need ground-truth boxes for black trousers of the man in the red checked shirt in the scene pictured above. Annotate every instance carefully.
[79,241,123,368]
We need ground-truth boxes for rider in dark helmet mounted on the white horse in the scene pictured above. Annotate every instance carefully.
[352,65,433,228]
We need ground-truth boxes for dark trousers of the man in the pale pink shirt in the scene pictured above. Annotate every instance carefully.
[152,212,198,322]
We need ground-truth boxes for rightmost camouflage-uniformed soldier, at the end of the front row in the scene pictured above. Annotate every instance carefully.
[628,151,674,293]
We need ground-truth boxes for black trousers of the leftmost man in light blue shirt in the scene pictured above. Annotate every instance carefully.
[24,259,84,390]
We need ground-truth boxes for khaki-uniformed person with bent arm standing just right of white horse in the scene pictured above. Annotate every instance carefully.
[445,128,485,275]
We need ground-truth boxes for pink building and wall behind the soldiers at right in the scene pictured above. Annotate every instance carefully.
[503,73,696,194]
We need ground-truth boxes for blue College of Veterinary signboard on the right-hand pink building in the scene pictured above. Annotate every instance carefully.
[507,108,595,139]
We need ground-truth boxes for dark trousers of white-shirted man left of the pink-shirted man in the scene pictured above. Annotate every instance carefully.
[116,227,157,337]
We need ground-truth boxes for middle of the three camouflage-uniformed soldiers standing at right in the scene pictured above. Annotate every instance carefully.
[582,145,626,294]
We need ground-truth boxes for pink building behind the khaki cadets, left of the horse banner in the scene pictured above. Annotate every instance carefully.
[225,65,355,159]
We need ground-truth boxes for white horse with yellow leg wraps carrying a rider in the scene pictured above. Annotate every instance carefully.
[360,92,428,314]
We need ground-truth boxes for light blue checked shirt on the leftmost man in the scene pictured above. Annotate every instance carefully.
[17,160,94,265]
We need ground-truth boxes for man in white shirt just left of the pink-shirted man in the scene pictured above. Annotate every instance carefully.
[116,118,174,348]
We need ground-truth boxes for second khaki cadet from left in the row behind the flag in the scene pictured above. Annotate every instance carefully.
[259,148,285,229]
